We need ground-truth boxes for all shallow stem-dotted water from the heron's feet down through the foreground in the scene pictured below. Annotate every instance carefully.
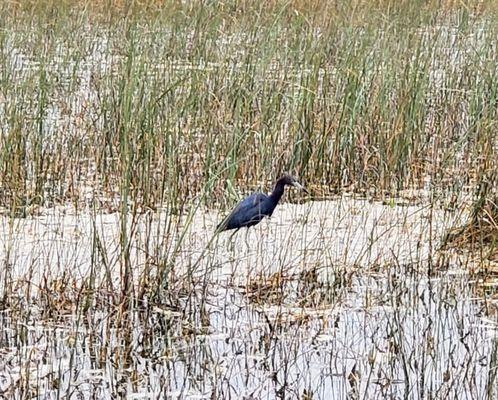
[0,197,498,399]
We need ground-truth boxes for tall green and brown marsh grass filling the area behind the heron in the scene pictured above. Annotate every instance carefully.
[0,1,497,213]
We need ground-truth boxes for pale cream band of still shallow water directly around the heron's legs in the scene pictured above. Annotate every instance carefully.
[0,196,462,283]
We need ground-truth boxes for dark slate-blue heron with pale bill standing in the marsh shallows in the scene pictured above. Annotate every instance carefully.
[216,175,309,232]
